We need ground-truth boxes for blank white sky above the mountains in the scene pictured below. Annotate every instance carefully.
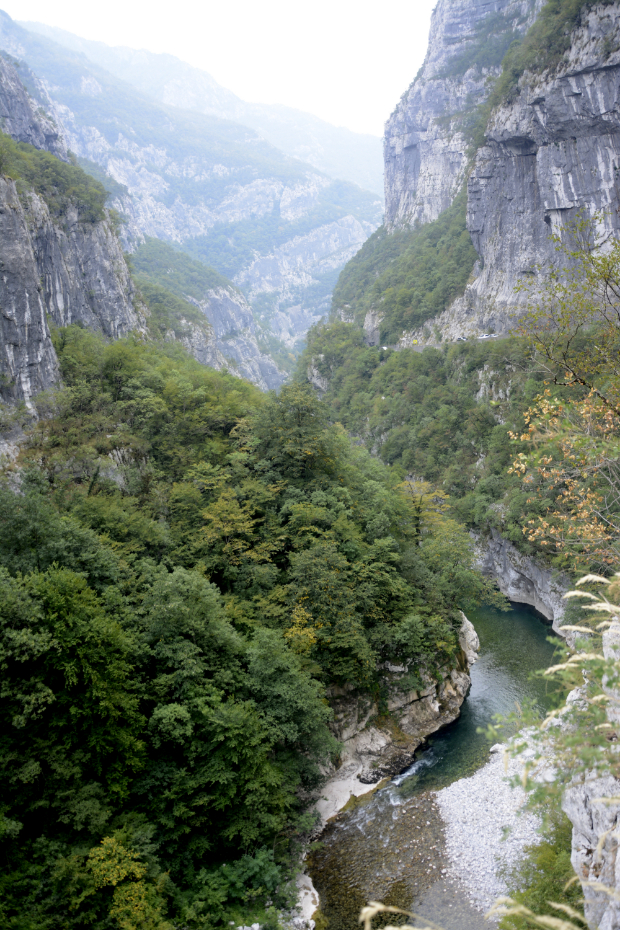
[0,0,436,136]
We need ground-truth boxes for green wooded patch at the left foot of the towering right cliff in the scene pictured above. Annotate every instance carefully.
[332,189,477,343]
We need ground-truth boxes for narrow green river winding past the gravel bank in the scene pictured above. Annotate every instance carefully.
[309,604,554,930]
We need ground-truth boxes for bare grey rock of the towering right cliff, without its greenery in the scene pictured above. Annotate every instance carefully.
[385,0,620,345]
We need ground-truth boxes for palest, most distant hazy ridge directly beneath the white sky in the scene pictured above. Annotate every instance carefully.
[22,22,383,195]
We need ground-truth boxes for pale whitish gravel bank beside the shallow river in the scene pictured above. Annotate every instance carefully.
[436,746,540,911]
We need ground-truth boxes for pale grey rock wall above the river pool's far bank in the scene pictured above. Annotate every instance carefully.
[476,528,570,636]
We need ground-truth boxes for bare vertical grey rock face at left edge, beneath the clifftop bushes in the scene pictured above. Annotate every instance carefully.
[0,177,144,405]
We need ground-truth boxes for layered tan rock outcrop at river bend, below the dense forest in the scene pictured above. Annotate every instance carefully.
[330,614,480,784]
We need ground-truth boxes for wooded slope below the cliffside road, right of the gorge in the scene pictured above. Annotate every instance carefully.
[300,322,550,551]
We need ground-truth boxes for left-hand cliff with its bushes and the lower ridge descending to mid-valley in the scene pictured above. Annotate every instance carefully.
[0,51,286,405]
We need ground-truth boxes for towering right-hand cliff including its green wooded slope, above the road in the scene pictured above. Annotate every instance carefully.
[322,0,620,345]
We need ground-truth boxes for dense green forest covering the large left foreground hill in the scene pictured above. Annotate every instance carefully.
[0,327,492,930]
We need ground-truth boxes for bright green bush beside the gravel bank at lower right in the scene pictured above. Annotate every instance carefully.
[500,809,583,930]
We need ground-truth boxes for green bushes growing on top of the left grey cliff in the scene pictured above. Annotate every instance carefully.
[0,132,107,223]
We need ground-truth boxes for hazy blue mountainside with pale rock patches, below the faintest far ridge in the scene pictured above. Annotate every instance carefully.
[0,14,381,356]
